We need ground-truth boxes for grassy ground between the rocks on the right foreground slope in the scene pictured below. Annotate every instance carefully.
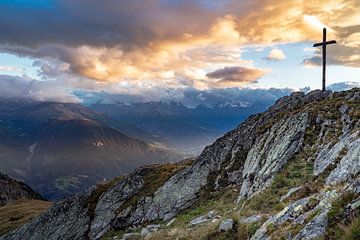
[104,89,360,240]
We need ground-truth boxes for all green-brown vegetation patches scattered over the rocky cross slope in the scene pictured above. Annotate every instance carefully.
[102,89,360,240]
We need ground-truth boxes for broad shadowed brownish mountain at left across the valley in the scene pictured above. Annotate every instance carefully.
[0,100,183,199]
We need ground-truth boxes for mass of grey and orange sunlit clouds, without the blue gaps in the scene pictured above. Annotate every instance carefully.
[0,0,360,97]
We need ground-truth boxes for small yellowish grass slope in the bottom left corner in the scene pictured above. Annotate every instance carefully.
[0,199,52,236]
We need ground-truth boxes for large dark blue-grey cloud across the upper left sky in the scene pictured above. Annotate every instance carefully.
[0,0,217,48]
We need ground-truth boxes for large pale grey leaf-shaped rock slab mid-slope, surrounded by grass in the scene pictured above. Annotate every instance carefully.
[239,113,308,200]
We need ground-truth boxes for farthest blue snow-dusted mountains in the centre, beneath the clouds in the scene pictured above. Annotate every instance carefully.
[89,101,271,154]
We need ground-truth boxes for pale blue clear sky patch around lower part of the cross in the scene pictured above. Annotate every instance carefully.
[243,42,360,89]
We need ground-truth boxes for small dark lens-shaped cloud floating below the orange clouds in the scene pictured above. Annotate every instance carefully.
[206,66,266,83]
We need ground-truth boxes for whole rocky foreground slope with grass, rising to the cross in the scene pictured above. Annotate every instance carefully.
[3,89,360,239]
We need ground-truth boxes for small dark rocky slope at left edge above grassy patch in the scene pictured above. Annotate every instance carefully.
[0,173,43,206]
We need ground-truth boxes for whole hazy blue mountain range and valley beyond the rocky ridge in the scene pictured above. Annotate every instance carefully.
[0,94,278,199]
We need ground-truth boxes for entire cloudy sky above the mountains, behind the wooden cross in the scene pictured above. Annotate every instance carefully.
[0,0,360,102]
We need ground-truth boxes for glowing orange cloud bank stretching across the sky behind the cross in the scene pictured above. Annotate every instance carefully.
[1,0,360,89]
